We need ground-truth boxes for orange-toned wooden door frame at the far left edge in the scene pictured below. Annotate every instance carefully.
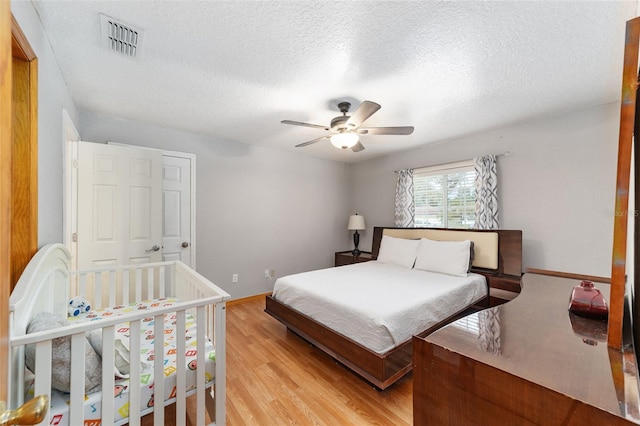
[0,7,38,402]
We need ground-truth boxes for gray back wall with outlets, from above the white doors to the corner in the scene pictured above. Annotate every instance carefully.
[80,113,350,298]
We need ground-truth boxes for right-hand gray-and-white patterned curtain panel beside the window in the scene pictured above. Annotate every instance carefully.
[473,155,500,229]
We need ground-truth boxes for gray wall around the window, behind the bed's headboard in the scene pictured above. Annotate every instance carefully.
[351,103,620,277]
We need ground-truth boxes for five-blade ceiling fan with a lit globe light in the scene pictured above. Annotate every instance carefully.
[281,101,413,152]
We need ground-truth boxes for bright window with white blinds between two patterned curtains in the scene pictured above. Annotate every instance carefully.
[413,161,476,229]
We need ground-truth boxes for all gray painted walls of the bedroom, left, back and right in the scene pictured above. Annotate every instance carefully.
[11,2,619,297]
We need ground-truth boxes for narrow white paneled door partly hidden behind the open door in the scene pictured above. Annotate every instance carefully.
[162,154,195,267]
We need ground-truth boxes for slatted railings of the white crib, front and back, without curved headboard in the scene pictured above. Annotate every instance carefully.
[11,261,230,425]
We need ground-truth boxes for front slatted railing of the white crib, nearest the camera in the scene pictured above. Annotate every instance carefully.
[11,298,225,425]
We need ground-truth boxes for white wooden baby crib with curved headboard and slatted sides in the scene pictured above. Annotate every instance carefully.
[9,244,230,425]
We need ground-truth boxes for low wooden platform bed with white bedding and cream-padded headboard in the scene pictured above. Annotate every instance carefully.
[265,227,522,389]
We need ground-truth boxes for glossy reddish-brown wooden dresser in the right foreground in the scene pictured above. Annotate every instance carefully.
[413,274,640,426]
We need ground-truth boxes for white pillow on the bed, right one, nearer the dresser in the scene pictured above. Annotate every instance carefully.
[415,238,471,277]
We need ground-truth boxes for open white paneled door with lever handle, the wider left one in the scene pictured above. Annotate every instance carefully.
[77,142,162,269]
